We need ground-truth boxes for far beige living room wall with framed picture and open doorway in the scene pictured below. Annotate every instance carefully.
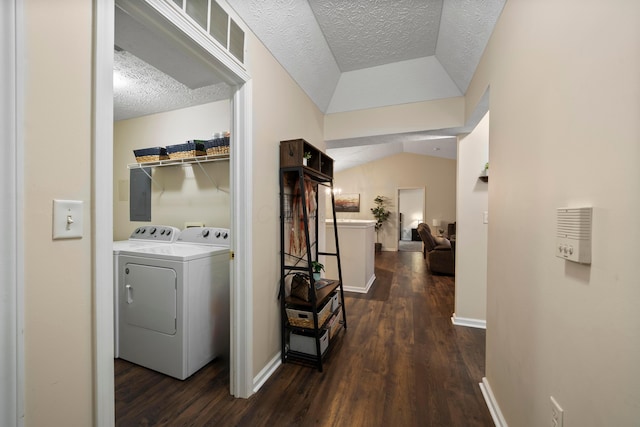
[327,153,456,250]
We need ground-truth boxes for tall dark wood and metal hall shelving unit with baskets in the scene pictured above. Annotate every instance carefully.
[280,139,347,372]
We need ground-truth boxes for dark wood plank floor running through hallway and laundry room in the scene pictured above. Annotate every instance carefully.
[115,252,493,427]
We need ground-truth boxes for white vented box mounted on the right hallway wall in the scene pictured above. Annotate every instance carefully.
[556,208,593,264]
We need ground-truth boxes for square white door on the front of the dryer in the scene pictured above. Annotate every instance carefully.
[120,263,177,335]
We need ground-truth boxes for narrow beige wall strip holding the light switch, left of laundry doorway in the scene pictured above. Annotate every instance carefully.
[22,0,93,427]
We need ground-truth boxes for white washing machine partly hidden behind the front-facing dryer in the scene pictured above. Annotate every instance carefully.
[113,225,180,357]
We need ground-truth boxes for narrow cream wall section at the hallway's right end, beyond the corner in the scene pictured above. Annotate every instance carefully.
[455,113,490,324]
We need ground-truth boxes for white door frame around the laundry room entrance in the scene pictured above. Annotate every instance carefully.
[92,0,253,427]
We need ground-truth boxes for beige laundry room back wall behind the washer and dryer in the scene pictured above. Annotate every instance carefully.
[113,101,231,240]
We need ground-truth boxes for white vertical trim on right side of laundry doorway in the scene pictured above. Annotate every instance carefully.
[230,80,253,398]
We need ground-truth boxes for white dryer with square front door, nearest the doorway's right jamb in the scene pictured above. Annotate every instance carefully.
[118,227,230,380]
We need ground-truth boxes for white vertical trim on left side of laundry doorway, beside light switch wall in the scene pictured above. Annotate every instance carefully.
[91,0,115,427]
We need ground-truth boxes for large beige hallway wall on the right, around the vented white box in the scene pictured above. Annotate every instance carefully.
[470,0,640,427]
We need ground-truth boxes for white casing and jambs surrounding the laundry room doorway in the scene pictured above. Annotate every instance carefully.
[93,0,253,425]
